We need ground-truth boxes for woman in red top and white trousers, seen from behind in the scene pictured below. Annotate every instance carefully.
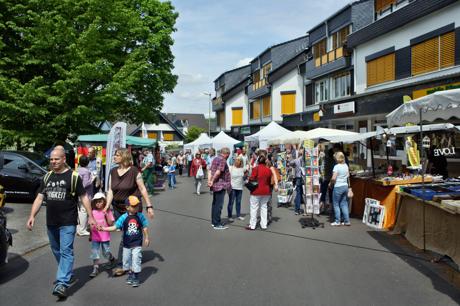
[246,155,278,231]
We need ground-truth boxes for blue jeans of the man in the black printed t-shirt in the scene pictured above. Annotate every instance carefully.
[48,225,77,287]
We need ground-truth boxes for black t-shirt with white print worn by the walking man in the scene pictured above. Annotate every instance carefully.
[39,170,85,226]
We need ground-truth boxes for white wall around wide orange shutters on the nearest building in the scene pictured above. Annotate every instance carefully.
[353,3,460,94]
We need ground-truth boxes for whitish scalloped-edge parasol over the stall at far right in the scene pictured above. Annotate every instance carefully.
[386,89,460,126]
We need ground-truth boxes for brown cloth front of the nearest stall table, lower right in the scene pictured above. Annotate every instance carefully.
[392,192,460,265]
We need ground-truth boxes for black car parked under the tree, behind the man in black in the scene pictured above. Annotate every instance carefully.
[0,151,48,202]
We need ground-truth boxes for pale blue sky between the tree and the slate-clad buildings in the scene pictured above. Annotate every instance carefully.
[163,0,350,115]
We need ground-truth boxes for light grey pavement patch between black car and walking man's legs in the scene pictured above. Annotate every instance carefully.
[5,203,48,260]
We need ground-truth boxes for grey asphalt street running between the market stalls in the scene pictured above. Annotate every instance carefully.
[0,178,460,306]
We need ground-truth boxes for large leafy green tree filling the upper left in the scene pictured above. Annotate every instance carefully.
[0,0,178,147]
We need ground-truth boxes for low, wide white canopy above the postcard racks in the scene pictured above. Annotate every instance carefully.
[268,128,360,144]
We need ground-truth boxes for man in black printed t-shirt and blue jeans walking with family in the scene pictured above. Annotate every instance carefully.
[27,149,95,298]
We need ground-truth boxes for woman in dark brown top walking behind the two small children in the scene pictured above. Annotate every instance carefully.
[105,149,154,276]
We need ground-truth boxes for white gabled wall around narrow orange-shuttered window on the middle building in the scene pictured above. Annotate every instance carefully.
[271,68,304,121]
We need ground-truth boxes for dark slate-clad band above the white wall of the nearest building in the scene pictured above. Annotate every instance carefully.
[348,0,457,48]
